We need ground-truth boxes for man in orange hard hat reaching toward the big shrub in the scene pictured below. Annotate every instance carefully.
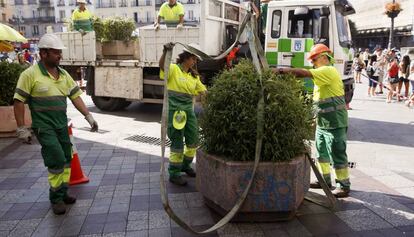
[273,44,351,197]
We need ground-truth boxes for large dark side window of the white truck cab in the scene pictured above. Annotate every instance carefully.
[288,9,320,40]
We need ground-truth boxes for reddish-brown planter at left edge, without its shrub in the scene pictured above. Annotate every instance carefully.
[0,105,32,137]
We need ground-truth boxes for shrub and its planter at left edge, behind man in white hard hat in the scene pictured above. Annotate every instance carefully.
[0,62,31,133]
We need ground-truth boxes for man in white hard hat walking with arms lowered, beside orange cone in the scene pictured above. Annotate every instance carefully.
[14,34,98,215]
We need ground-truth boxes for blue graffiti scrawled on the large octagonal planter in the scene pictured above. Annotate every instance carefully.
[238,171,294,211]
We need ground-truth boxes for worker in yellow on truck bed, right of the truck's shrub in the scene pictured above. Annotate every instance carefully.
[154,0,184,30]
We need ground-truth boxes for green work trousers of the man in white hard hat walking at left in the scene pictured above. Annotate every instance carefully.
[33,127,72,203]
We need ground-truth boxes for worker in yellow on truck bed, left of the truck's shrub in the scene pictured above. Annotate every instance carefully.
[72,0,93,32]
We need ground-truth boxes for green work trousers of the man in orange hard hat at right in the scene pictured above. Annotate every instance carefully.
[315,127,351,188]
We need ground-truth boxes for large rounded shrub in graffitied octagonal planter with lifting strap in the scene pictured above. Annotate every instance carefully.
[196,61,312,221]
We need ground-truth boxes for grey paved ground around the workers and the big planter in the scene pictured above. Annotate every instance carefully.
[0,81,414,237]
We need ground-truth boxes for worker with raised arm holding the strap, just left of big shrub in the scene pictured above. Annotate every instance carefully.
[159,43,206,185]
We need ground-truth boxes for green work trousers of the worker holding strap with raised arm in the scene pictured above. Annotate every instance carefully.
[167,109,198,177]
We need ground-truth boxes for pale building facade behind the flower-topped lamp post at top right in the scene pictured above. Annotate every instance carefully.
[350,0,414,49]
